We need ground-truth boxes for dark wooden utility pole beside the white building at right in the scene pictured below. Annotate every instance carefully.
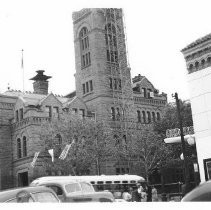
[172,93,190,194]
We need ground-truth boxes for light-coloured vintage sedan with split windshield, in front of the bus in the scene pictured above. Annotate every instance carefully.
[31,176,115,202]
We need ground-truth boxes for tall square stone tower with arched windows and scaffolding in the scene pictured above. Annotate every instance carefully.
[73,8,133,124]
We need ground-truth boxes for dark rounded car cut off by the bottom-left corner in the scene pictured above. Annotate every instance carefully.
[0,186,60,203]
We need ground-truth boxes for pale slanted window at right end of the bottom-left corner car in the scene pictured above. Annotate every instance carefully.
[33,192,59,203]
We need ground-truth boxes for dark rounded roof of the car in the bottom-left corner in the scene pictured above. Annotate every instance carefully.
[0,186,53,202]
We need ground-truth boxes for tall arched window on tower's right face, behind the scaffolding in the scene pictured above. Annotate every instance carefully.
[105,23,118,63]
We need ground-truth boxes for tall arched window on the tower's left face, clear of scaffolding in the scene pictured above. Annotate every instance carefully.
[79,27,91,68]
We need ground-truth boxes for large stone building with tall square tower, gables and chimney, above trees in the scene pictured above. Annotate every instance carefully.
[0,9,167,189]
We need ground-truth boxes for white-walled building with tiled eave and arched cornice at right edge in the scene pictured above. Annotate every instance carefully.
[182,34,211,181]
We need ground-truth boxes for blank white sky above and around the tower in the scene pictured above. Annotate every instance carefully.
[0,0,211,101]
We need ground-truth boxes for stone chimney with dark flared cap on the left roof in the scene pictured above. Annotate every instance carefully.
[30,70,51,95]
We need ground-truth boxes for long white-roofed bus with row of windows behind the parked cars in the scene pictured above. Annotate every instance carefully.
[33,174,145,198]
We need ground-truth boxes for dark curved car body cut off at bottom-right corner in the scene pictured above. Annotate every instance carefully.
[181,181,211,202]
